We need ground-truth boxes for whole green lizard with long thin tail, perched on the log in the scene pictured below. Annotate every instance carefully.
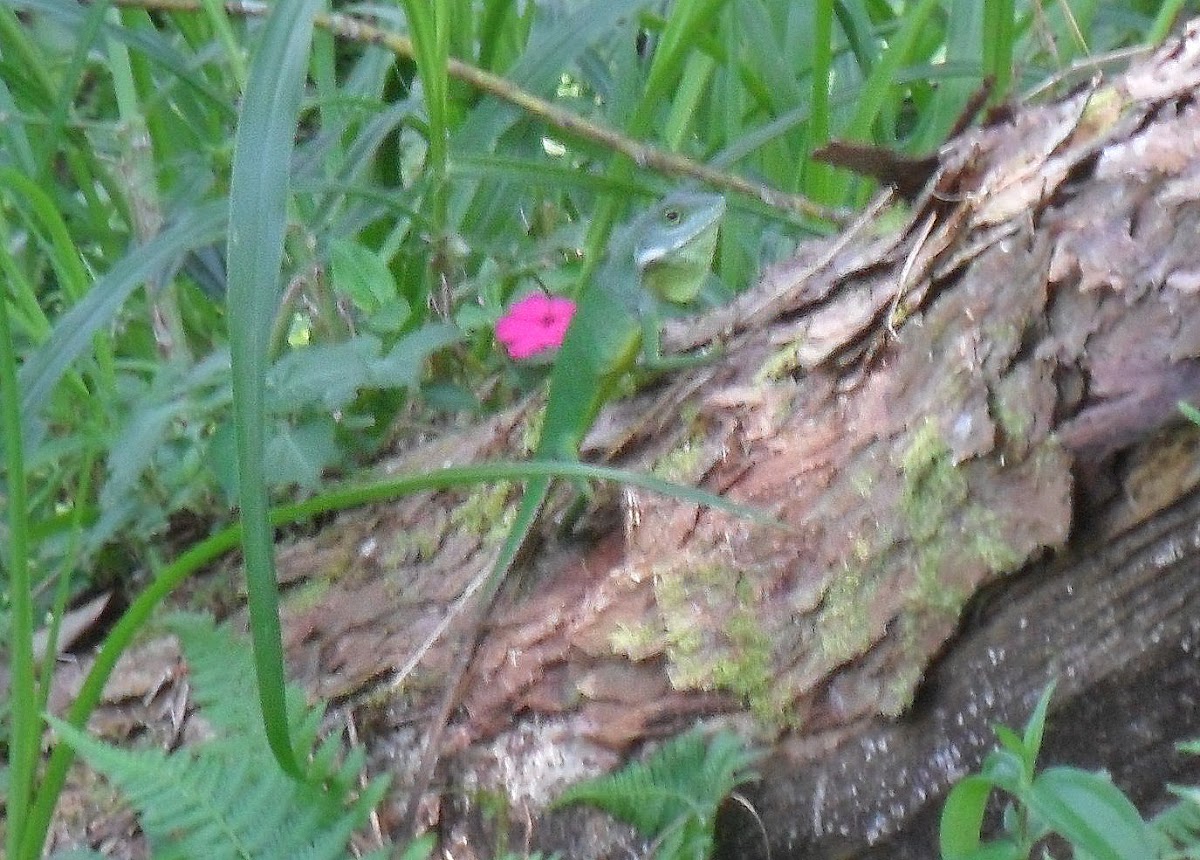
[409,192,725,820]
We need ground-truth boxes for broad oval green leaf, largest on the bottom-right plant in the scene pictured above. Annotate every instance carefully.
[1026,768,1151,860]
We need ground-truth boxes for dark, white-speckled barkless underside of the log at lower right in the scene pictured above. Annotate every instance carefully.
[719,477,1200,860]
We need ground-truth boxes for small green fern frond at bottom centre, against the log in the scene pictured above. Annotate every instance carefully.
[554,729,757,860]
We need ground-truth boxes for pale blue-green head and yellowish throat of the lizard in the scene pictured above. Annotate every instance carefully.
[632,191,725,305]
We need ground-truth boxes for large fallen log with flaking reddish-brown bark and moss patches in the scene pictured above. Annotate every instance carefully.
[56,18,1200,860]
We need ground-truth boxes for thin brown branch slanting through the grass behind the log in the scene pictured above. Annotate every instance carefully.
[100,0,848,224]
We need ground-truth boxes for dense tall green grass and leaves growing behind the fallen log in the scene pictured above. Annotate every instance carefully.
[0,0,1200,859]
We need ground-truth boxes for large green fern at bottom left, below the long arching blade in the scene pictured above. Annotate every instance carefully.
[52,615,386,860]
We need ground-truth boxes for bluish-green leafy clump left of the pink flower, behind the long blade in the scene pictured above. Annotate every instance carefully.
[97,324,461,537]
